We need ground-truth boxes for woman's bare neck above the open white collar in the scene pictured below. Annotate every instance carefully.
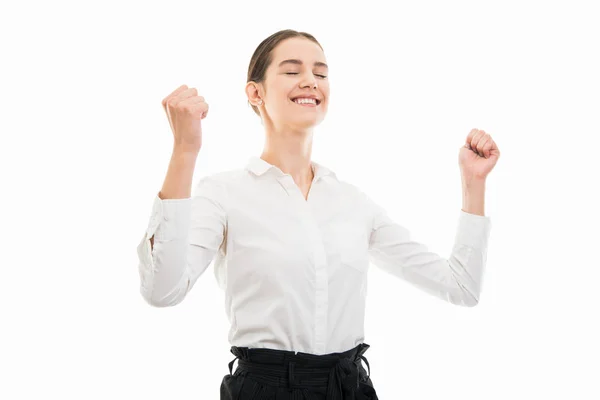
[260,123,314,184]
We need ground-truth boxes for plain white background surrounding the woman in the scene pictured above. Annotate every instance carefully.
[0,0,600,400]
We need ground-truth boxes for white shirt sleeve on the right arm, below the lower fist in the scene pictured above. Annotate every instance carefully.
[368,194,491,307]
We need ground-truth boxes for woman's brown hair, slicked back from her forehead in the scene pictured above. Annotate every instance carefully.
[246,29,323,117]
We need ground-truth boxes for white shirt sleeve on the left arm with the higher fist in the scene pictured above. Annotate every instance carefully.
[137,177,227,307]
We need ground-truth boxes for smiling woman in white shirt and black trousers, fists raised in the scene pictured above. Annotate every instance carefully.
[138,30,499,400]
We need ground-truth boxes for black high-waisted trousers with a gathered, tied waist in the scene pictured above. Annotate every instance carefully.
[221,343,378,400]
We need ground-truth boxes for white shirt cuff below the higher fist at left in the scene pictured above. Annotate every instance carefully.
[146,193,192,242]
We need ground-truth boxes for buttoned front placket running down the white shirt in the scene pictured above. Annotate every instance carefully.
[281,175,329,354]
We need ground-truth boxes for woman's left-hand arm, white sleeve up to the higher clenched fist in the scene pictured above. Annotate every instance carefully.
[137,85,227,307]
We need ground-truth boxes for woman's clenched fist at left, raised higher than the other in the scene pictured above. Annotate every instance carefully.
[162,85,208,153]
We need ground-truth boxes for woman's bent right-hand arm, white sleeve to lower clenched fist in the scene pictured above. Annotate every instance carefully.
[367,129,500,307]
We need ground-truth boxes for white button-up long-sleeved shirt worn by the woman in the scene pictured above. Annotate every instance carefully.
[137,157,491,354]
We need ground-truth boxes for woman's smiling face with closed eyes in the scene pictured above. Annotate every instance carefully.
[252,37,329,129]
